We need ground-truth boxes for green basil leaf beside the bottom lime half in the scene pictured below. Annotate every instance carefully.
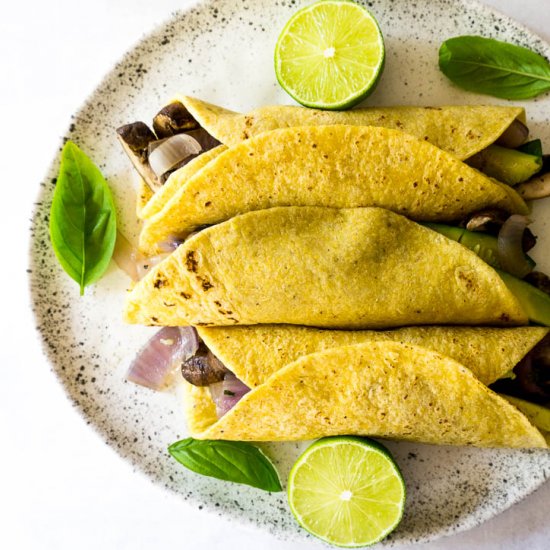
[168,437,283,493]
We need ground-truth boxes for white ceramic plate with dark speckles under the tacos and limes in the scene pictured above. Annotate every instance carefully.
[30,0,550,545]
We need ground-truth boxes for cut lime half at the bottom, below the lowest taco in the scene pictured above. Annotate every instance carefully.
[288,436,405,548]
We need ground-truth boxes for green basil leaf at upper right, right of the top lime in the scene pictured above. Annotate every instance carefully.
[439,36,550,99]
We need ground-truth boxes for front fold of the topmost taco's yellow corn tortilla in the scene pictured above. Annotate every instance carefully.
[140,125,528,255]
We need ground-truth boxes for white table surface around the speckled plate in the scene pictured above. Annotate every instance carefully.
[6,0,550,550]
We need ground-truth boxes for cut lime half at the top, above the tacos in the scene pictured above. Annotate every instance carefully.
[275,0,384,109]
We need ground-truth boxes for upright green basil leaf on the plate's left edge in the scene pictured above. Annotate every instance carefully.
[50,141,116,295]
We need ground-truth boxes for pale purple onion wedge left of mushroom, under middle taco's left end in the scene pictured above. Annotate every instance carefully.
[126,327,199,391]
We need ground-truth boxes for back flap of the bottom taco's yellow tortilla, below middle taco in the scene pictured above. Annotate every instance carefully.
[198,325,550,388]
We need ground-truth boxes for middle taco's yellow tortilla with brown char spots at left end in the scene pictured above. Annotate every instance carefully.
[125,207,528,328]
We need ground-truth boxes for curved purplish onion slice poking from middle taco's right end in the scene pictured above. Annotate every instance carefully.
[498,214,533,279]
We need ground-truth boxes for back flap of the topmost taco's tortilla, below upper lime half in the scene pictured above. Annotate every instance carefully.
[174,95,525,160]
